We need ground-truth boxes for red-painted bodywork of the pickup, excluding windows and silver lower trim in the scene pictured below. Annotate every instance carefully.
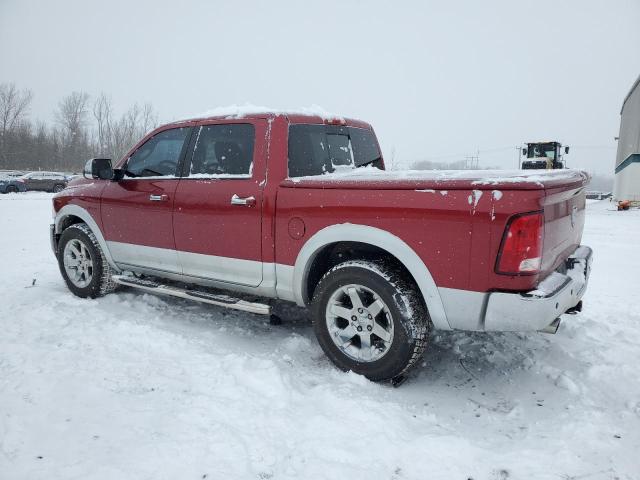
[54,114,585,292]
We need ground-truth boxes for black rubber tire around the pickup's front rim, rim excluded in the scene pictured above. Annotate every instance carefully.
[57,223,117,298]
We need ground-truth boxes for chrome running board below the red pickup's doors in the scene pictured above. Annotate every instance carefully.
[111,275,271,315]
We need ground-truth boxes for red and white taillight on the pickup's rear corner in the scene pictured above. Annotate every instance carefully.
[496,212,544,275]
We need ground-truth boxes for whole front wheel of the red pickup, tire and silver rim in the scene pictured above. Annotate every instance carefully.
[58,223,116,298]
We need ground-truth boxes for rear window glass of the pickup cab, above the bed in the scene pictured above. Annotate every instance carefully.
[289,124,382,177]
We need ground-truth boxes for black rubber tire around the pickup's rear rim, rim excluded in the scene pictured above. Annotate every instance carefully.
[311,260,431,381]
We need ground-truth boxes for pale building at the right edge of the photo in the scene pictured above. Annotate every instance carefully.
[613,77,640,202]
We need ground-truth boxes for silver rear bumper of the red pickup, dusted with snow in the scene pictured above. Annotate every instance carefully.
[484,245,593,331]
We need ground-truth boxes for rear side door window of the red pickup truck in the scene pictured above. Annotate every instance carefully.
[189,123,255,178]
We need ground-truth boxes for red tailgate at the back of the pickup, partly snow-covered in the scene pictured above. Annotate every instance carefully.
[541,183,588,274]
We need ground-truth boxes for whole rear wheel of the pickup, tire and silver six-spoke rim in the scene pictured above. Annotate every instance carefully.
[311,260,430,381]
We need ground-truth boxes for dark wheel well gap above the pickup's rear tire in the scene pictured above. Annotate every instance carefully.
[302,242,416,304]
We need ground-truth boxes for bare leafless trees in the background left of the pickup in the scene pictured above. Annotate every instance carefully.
[0,83,158,172]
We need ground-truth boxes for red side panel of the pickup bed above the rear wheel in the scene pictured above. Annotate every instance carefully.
[275,184,543,292]
